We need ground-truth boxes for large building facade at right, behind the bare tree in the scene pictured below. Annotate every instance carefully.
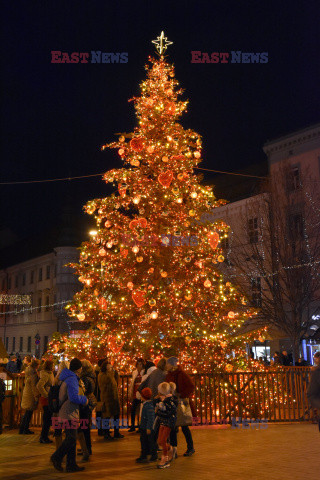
[211,124,320,360]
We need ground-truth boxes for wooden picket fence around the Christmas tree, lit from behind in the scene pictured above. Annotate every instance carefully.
[3,367,313,427]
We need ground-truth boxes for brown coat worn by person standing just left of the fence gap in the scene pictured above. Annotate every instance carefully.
[98,371,120,418]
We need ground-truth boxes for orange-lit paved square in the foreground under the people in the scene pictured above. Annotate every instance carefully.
[0,423,320,480]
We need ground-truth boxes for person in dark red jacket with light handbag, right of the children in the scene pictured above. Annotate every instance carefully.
[166,357,195,457]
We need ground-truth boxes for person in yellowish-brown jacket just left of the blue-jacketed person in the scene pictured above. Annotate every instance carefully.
[37,360,54,443]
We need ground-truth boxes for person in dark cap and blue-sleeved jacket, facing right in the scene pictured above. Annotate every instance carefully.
[50,358,88,472]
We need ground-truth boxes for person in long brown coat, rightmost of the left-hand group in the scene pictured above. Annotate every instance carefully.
[98,362,123,440]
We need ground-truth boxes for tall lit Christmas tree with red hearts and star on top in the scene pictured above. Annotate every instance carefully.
[53,34,262,371]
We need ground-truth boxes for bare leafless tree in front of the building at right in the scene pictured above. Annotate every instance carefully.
[219,165,320,360]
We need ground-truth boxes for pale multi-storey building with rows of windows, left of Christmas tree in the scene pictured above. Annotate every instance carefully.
[0,247,80,356]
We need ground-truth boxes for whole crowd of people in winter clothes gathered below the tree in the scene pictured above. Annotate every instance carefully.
[0,356,195,472]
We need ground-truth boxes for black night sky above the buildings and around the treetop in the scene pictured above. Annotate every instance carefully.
[0,0,320,244]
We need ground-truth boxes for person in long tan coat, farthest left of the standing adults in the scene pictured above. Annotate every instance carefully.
[19,358,39,435]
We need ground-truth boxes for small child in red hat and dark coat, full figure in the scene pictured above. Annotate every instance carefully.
[136,387,158,463]
